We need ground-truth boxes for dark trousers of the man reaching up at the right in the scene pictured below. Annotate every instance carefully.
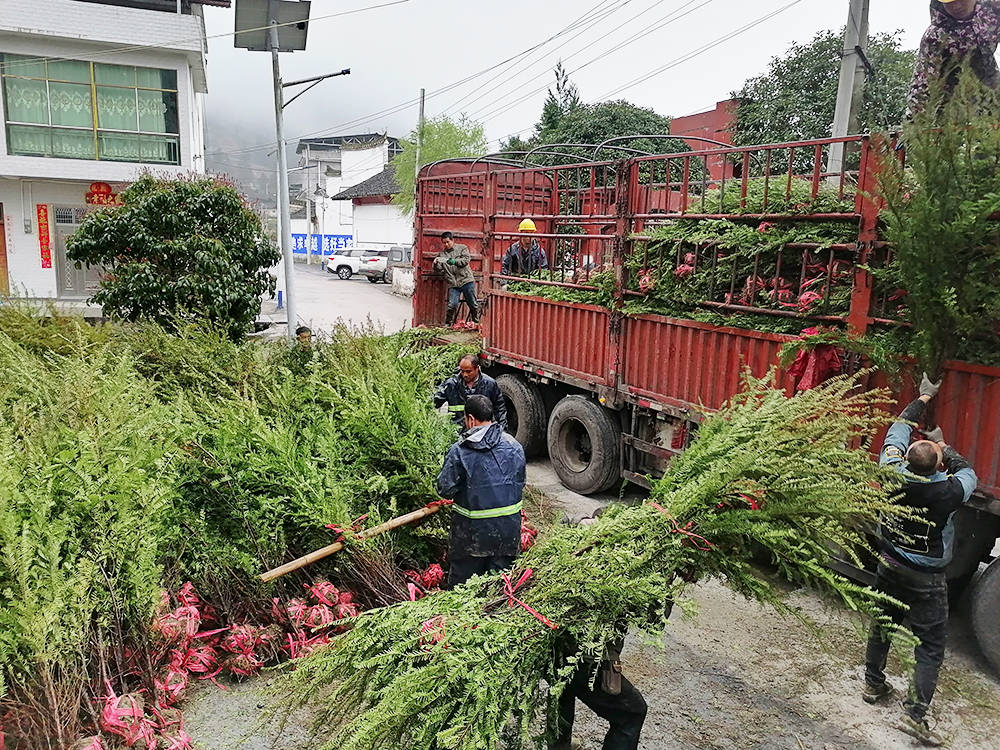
[865,563,948,719]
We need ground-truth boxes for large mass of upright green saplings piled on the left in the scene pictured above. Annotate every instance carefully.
[0,306,466,747]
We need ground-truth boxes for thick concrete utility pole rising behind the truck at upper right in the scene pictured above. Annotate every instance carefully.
[826,0,871,179]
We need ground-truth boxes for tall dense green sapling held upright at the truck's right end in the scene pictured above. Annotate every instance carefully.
[881,75,1000,373]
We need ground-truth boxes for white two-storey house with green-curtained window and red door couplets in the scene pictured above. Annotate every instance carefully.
[0,0,221,307]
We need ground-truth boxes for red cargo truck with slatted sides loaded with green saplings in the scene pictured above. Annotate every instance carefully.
[413,138,1000,669]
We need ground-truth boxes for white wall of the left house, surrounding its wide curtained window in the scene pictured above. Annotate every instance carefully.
[0,0,206,298]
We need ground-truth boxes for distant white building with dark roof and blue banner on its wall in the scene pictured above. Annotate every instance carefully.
[292,133,413,256]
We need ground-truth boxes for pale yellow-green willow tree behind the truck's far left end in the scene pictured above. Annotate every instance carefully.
[392,115,488,213]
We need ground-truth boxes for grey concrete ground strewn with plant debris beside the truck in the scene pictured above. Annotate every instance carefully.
[185,463,1000,750]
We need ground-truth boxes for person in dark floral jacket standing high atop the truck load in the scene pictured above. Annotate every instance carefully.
[907,0,1000,116]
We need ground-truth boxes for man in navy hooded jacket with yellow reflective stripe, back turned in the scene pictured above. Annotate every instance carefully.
[437,395,525,588]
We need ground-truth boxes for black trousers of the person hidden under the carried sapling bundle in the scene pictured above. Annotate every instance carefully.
[555,669,646,750]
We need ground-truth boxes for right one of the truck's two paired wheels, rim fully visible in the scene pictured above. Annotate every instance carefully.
[548,396,621,495]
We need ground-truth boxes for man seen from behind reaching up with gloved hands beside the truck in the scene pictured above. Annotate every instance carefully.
[862,373,978,747]
